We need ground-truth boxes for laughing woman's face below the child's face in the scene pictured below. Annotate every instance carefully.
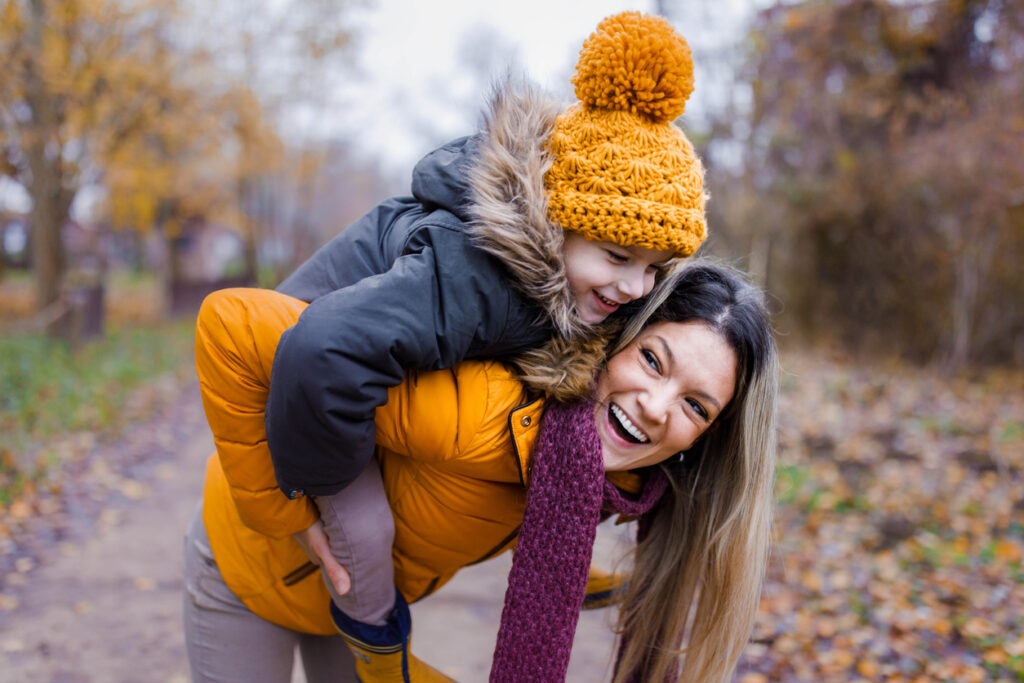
[594,323,736,471]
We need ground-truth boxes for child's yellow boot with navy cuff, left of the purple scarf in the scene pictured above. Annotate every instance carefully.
[331,591,455,683]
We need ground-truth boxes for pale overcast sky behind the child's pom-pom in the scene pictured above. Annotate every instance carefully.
[0,0,770,210]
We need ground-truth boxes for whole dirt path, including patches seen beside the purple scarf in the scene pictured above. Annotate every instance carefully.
[0,386,626,683]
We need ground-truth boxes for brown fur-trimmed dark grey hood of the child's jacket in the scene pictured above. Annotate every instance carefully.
[413,79,617,400]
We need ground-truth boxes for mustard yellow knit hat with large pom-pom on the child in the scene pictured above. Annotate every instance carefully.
[544,12,708,256]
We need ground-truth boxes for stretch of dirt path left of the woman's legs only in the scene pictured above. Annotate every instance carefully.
[0,388,213,683]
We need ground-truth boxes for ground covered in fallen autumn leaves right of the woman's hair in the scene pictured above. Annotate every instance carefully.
[735,354,1024,683]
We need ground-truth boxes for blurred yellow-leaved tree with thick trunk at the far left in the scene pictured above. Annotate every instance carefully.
[0,0,192,317]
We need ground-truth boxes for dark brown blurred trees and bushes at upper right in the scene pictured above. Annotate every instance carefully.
[711,0,1024,366]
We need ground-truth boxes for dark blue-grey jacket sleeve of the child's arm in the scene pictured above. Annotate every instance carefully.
[266,226,520,496]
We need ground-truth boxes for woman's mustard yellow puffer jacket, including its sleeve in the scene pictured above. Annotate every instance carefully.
[196,289,544,634]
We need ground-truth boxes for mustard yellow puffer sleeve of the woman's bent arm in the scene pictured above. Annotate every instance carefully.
[196,289,317,538]
